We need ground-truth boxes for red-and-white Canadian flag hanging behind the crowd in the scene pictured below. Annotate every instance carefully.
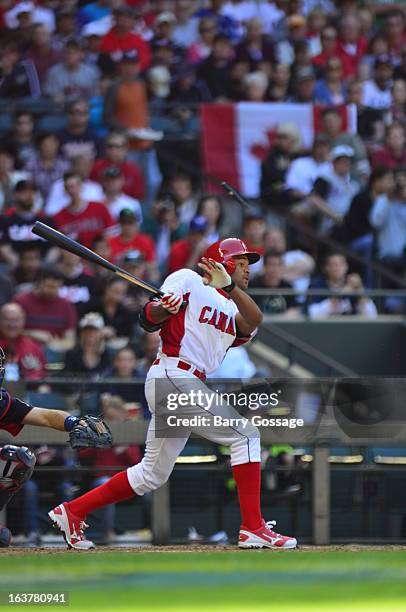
[201,102,357,198]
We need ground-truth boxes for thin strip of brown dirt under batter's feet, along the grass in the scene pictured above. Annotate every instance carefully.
[0,544,406,557]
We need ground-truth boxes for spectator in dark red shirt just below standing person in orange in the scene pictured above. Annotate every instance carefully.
[90,132,144,200]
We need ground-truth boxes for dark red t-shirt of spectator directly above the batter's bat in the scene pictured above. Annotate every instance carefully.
[54,202,115,247]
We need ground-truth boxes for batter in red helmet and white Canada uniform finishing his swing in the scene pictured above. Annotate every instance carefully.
[49,238,297,550]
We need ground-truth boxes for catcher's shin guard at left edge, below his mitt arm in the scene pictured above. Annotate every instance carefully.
[0,444,36,510]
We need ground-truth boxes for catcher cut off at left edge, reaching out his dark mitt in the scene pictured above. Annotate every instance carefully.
[0,347,113,547]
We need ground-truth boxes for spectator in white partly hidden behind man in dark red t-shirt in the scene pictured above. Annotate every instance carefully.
[45,154,104,215]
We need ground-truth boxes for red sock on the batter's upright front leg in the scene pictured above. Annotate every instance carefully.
[233,461,262,531]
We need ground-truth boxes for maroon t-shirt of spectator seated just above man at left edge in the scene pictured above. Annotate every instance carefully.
[14,291,77,337]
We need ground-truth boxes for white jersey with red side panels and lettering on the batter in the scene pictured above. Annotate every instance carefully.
[153,269,254,374]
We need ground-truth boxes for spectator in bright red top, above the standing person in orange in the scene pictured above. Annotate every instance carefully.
[99,6,151,74]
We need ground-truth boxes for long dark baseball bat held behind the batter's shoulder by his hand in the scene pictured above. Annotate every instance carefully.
[32,221,163,297]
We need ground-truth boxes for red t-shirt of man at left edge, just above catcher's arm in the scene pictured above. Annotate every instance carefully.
[0,336,47,380]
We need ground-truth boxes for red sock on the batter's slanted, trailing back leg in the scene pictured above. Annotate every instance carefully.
[66,471,135,518]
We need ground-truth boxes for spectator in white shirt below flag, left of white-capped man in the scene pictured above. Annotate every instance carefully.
[285,134,329,202]
